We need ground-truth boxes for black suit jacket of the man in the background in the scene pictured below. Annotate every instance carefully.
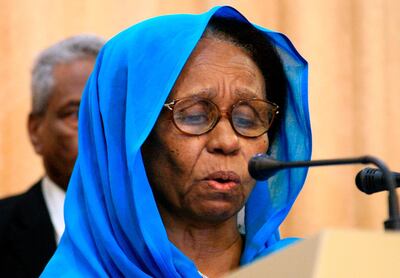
[0,182,57,277]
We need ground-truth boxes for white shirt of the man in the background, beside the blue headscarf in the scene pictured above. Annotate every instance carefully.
[42,176,65,244]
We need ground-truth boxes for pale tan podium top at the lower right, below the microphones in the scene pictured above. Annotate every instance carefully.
[228,230,400,278]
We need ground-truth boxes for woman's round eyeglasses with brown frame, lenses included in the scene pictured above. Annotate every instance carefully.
[164,97,279,137]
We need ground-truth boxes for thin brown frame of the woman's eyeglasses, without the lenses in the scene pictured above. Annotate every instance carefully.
[163,96,279,138]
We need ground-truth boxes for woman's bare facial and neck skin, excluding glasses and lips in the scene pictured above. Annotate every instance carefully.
[142,38,268,276]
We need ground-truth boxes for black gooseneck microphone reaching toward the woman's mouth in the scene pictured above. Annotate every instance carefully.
[248,154,400,231]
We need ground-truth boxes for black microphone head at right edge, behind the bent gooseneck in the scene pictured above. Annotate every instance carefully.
[356,168,400,194]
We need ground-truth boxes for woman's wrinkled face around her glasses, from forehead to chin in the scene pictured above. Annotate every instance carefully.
[142,38,268,223]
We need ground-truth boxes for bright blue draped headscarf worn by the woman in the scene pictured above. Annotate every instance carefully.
[43,7,311,277]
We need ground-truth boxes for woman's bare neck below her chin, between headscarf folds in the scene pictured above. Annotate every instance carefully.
[163,211,243,277]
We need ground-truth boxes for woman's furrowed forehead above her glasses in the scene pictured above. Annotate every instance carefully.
[170,38,265,101]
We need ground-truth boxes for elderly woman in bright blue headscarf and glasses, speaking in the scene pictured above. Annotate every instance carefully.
[44,4,311,277]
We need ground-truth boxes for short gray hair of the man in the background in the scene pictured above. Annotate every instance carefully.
[31,35,105,114]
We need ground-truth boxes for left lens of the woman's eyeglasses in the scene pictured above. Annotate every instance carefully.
[174,98,218,135]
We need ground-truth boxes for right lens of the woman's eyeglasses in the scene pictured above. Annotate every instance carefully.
[232,100,276,137]
